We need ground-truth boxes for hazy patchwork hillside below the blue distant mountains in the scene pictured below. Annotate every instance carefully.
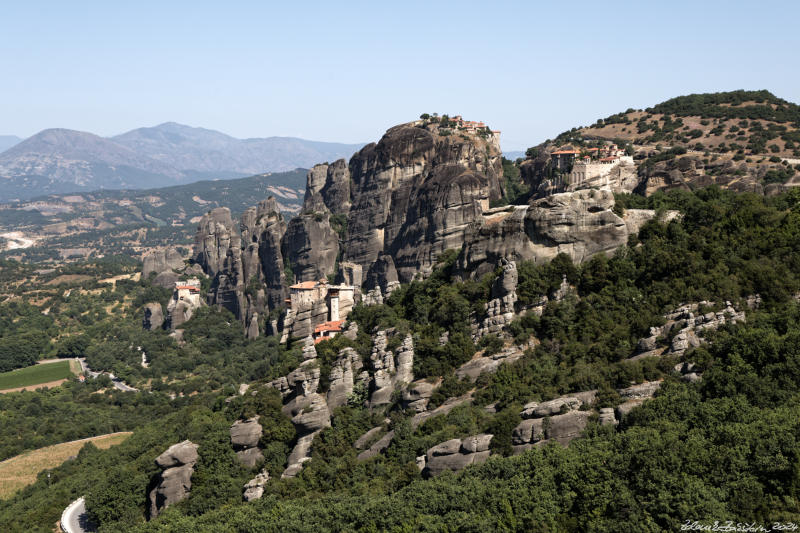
[0,169,306,261]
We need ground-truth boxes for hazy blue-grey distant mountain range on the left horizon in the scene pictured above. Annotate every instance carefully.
[0,122,363,201]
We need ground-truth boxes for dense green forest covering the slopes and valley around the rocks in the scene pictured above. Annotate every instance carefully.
[0,188,800,533]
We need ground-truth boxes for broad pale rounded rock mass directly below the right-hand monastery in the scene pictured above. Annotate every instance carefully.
[458,190,655,276]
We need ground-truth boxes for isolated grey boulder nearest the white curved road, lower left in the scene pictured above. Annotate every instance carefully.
[149,440,198,519]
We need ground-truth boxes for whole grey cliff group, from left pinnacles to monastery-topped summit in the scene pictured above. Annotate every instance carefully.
[194,120,503,330]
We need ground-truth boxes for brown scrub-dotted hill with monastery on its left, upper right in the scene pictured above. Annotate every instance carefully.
[519,91,800,198]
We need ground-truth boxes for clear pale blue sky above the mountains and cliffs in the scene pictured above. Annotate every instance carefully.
[0,0,800,151]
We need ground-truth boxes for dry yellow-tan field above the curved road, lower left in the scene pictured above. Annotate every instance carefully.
[0,432,131,499]
